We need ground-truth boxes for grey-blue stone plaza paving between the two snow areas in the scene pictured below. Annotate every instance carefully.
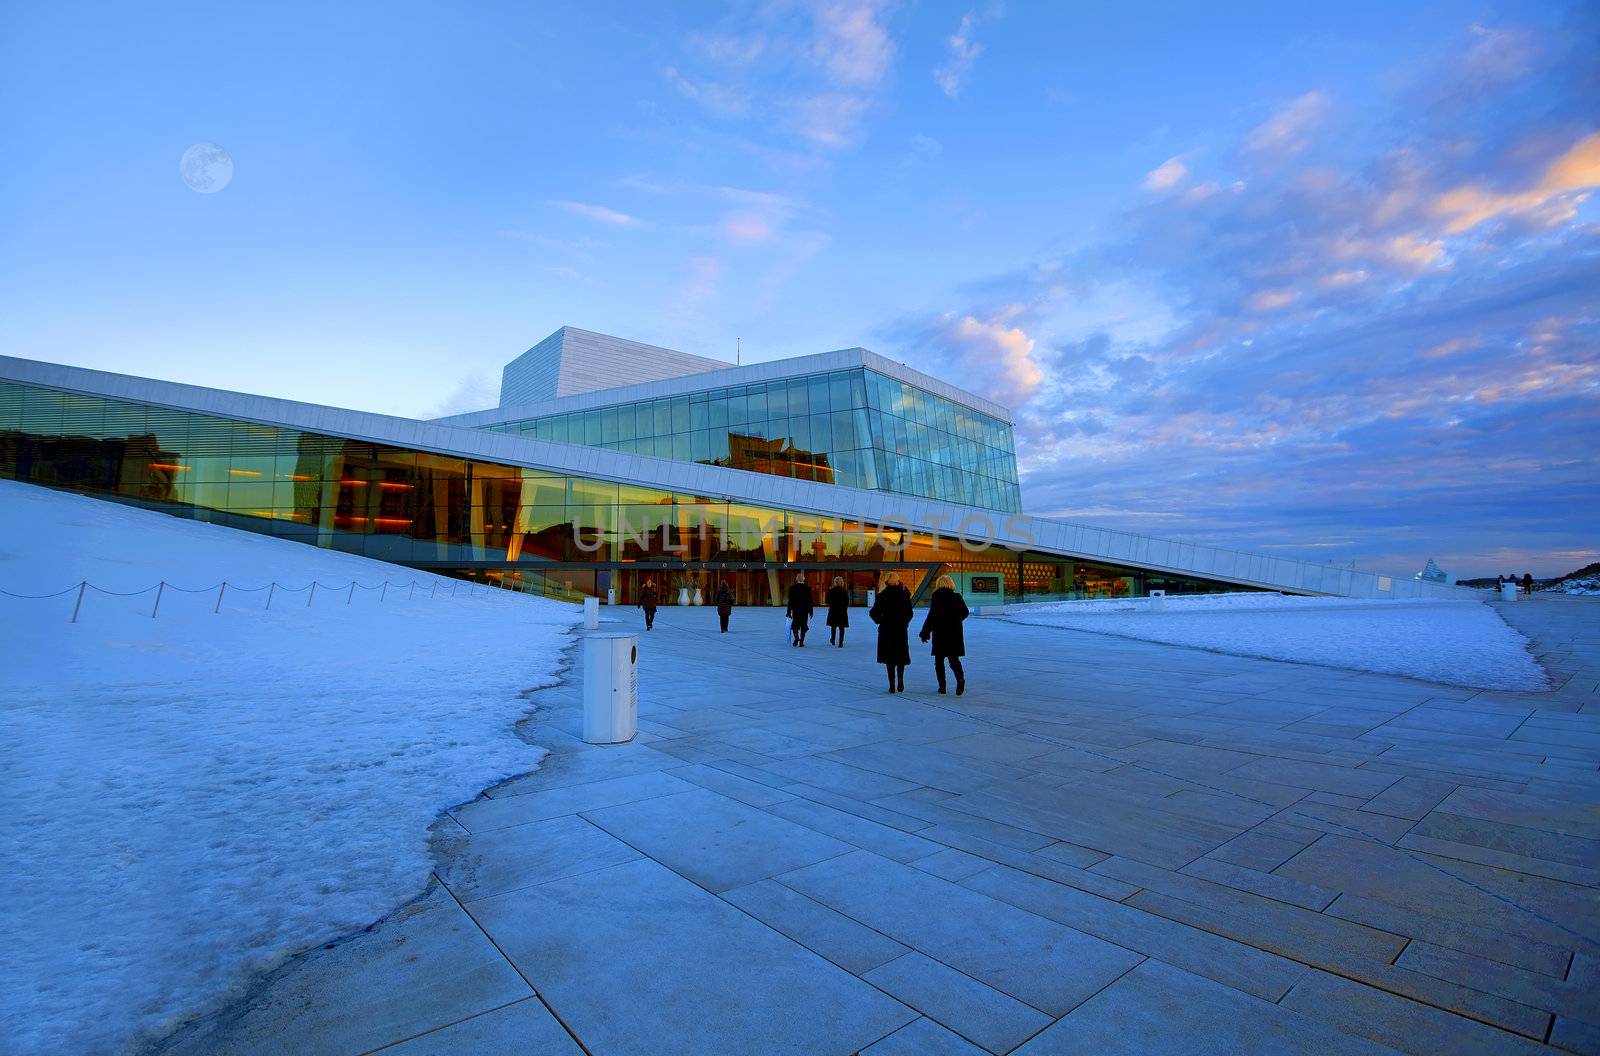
[160,597,1600,1056]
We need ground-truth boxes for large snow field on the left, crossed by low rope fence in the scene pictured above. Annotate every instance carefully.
[0,482,579,1054]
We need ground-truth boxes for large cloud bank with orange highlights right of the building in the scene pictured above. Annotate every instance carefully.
[882,18,1600,574]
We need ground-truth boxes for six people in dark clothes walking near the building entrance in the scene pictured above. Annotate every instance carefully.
[638,571,968,696]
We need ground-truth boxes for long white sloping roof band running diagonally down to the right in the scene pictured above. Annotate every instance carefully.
[0,354,1483,600]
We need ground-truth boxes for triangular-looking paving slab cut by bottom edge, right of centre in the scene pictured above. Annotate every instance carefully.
[1018,960,1395,1056]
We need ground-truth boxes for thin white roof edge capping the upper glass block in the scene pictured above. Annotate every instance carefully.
[435,334,1011,429]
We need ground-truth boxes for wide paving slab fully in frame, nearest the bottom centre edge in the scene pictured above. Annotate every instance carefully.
[778,851,1139,1016]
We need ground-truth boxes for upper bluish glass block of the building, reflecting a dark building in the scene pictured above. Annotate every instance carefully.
[488,368,1021,514]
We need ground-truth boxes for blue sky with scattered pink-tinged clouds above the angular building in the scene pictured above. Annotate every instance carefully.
[0,0,1600,574]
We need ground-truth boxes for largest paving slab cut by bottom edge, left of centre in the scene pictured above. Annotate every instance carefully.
[472,861,917,1056]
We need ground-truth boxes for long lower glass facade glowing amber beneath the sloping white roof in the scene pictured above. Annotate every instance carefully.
[0,382,1248,603]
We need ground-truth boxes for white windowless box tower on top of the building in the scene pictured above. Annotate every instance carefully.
[501,326,726,406]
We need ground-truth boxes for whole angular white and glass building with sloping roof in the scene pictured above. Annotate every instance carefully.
[0,326,1454,605]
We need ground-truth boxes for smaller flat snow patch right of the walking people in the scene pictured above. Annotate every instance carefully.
[1005,592,1549,690]
